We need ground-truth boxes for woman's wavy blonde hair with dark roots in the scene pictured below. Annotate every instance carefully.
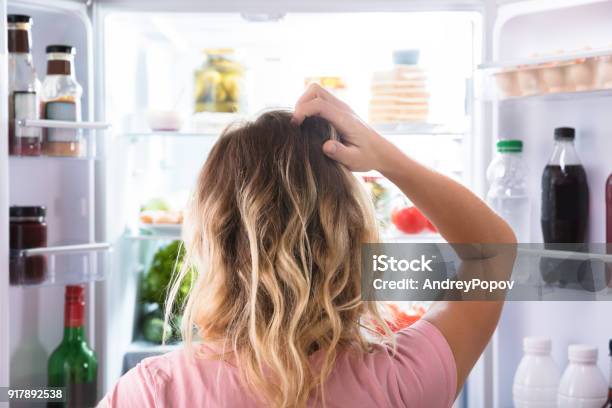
[166,111,390,407]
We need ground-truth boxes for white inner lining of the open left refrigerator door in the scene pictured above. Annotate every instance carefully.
[2,1,101,396]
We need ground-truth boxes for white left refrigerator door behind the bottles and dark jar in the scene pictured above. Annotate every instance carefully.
[0,0,106,400]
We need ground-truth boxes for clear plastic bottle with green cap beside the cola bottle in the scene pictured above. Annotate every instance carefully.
[487,140,529,243]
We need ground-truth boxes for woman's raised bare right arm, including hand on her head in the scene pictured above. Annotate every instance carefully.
[294,85,516,392]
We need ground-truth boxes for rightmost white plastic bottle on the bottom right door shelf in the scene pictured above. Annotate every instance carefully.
[557,344,608,408]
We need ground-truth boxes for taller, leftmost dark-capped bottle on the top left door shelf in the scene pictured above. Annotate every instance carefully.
[7,14,42,156]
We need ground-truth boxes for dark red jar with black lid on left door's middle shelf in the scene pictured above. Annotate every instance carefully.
[9,206,47,284]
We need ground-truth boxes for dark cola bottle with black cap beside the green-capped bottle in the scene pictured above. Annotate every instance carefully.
[540,127,590,285]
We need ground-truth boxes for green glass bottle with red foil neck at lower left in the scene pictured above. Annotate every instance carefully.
[47,286,98,408]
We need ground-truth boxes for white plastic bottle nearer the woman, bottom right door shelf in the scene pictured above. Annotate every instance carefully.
[512,337,561,408]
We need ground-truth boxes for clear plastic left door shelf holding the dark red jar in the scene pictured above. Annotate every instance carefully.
[10,242,111,286]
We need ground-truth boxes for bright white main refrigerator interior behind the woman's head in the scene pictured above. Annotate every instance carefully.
[99,8,482,392]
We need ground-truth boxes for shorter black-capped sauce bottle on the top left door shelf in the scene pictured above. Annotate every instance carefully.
[42,45,85,157]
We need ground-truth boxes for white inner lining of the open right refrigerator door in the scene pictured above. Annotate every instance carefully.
[493,1,612,407]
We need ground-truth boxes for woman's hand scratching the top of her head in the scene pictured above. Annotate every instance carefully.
[292,83,385,171]
